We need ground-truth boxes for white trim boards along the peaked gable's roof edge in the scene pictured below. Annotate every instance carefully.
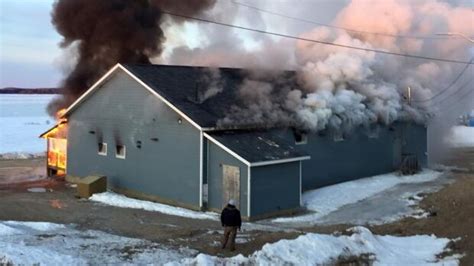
[62,64,202,131]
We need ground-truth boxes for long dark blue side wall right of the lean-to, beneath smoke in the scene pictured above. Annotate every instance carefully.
[276,123,427,190]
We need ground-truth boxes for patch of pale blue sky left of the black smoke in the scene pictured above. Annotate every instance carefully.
[0,0,62,87]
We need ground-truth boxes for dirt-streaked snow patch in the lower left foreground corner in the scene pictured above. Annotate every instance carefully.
[0,221,196,265]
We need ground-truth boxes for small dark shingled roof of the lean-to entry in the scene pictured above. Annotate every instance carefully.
[208,130,308,163]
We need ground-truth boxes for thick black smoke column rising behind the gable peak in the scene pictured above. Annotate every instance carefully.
[48,0,215,114]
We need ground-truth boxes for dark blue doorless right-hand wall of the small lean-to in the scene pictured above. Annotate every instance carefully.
[250,161,300,216]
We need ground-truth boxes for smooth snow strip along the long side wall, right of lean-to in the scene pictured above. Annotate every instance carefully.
[273,170,442,222]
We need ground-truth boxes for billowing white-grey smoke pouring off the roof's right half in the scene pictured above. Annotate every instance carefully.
[167,0,474,158]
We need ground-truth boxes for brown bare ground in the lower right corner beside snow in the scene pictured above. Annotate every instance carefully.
[370,173,474,265]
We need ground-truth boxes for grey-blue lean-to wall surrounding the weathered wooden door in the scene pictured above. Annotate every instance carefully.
[207,141,249,217]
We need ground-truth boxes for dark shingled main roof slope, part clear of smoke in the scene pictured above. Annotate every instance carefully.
[124,64,296,128]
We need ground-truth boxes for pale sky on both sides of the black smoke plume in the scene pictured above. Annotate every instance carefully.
[0,0,472,88]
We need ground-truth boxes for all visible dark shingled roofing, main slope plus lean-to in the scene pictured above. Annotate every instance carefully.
[124,65,307,163]
